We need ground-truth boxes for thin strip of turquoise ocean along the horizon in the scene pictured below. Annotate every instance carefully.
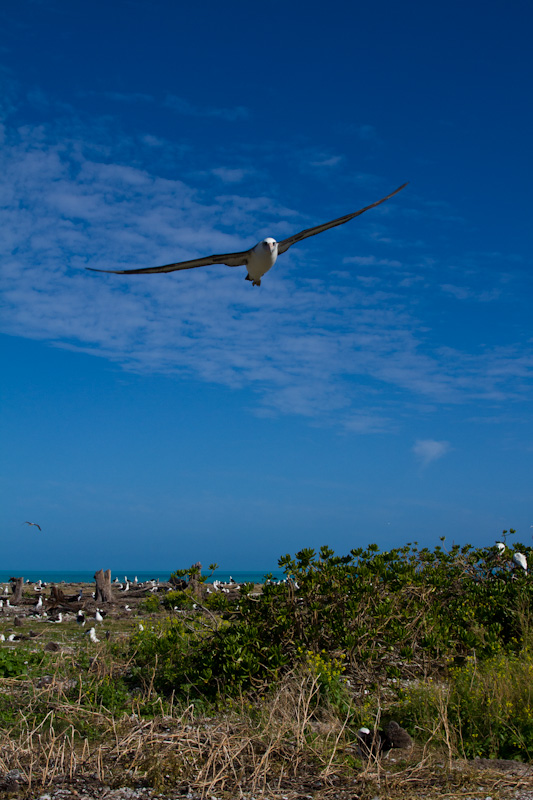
[0,569,285,583]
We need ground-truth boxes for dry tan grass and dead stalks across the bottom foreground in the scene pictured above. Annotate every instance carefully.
[0,671,533,800]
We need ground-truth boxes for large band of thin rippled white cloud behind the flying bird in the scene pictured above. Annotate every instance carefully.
[0,109,533,433]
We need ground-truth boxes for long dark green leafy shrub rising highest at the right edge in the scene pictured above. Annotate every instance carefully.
[132,543,533,720]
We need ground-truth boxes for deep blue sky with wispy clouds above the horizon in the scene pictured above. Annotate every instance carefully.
[0,0,533,570]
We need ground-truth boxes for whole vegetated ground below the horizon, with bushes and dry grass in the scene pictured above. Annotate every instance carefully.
[0,545,533,799]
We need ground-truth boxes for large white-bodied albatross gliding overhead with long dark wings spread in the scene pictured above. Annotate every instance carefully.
[87,183,407,286]
